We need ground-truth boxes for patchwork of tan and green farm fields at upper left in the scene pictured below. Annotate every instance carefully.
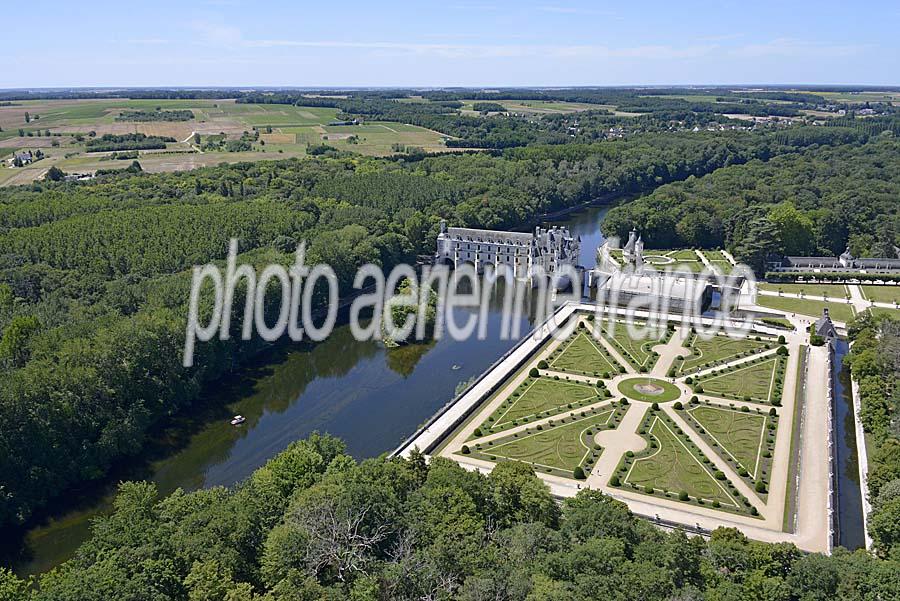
[0,99,449,185]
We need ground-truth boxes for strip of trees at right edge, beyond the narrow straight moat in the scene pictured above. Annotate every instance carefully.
[844,312,900,556]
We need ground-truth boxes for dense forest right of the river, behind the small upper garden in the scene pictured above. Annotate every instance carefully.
[603,135,900,273]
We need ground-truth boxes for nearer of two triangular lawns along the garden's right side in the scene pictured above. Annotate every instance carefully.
[685,405,769,480]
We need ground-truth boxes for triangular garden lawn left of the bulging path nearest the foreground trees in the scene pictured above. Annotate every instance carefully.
[474,407,614,477]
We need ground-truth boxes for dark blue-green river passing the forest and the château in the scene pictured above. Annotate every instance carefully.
[8,207,607,574]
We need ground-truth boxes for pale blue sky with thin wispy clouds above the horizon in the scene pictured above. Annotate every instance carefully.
[7,0,900,88]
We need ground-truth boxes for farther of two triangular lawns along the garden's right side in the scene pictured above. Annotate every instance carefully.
[697,356,785,403]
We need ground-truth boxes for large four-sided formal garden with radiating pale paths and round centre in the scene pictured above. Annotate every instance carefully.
[453,314,800,517]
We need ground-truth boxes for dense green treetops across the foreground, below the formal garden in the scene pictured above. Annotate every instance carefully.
[0,435,900,601]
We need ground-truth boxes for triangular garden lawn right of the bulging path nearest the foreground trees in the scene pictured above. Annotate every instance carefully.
[623,415,738,508]
